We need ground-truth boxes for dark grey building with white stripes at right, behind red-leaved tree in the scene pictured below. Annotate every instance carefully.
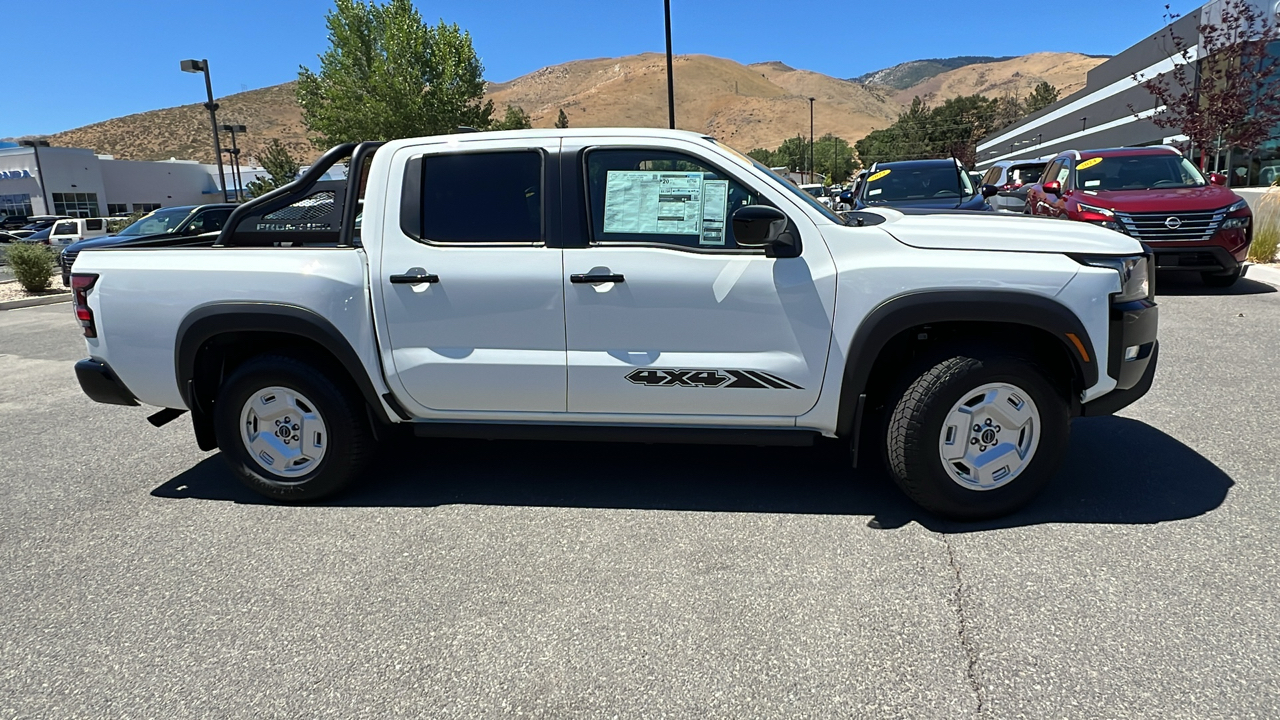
[977,0,1280,187]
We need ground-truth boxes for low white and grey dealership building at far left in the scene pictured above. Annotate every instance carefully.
[0,145,265,218]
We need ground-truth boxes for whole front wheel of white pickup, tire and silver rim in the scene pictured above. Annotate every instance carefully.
[884,355,1070,520]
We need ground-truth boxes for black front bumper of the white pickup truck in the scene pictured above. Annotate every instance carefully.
[1080,300,1160,416]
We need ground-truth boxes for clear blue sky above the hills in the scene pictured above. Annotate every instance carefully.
[0,0,1202,137]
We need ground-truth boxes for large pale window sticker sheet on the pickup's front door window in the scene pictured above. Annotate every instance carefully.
[604,170,706,236]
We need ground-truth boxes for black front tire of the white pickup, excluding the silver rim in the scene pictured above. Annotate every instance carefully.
[884,354,1070,520]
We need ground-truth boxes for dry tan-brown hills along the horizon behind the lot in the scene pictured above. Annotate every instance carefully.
[37,53,1102,163]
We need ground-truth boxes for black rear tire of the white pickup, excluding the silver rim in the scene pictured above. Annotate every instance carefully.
[214,355,374,502]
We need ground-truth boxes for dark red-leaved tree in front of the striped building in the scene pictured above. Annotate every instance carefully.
[1129,0,1280,168]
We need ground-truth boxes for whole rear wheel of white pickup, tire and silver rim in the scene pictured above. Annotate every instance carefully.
[214,355,374,502]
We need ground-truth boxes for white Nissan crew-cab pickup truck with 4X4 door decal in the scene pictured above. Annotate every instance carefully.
[72,129,1157,519]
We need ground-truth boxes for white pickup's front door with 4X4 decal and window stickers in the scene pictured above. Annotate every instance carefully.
[563,141,836,423]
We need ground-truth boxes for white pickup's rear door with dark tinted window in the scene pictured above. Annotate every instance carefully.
[373,138,566,418]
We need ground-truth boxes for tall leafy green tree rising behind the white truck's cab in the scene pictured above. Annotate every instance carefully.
[297,0,493,147]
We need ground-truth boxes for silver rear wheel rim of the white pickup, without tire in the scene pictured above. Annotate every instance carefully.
[241,386,329,479]
